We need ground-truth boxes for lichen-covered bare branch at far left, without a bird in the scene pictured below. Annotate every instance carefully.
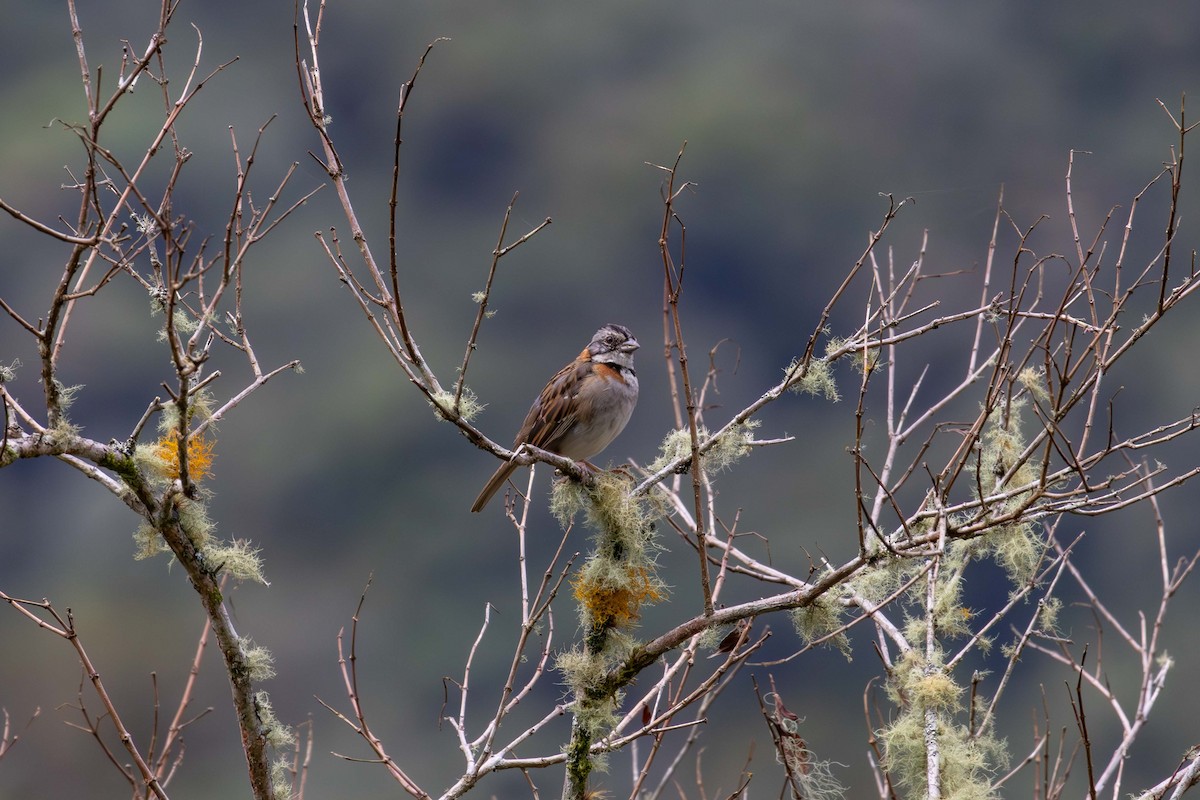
[0,0,312,799]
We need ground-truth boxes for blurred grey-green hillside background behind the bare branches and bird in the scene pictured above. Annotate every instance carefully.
[0,0,1200,799]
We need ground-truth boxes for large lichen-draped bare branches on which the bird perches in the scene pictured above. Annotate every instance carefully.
[288,10,1200,799]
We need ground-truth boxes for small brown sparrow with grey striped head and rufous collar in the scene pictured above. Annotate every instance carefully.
[470,324,638,511]
